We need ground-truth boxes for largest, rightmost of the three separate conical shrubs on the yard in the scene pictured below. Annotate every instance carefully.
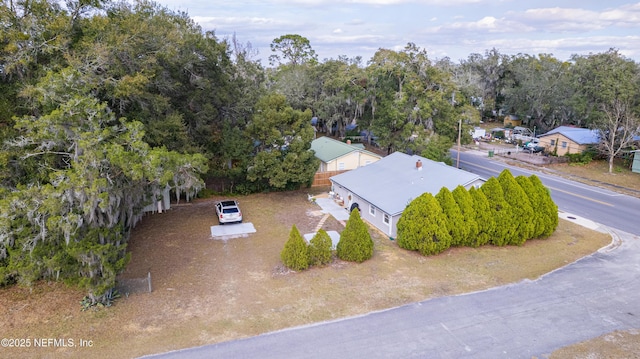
[336,209,373,263]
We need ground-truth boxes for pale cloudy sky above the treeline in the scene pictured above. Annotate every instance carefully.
[156,0,640,65]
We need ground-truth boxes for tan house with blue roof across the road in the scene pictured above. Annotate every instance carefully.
[538,126,600,156]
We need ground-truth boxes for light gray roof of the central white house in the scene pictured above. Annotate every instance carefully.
[331,152,480,215]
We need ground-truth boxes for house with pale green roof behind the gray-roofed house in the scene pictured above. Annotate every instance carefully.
[311,137,382,172]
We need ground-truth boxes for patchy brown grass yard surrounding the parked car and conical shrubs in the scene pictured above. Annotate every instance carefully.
[0,191,611,358]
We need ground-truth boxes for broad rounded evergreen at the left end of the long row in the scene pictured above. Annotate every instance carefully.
[398,192,451,256]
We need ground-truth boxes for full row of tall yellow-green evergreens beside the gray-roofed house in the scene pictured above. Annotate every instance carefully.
[397,169,558,255]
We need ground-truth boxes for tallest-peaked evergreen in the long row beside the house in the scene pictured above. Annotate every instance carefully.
[498,169,535,246]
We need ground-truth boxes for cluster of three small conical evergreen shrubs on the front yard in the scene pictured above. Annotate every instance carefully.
[280,210,373,270]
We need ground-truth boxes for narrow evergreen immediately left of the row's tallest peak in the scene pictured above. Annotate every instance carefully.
[480,177,516,246]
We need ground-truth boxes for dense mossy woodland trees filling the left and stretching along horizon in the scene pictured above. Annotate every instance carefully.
[0,0,640,302]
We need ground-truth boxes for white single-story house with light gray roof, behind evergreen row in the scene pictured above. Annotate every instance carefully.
[331,152,485,238]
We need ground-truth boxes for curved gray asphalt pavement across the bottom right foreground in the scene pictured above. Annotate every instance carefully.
[145,231,640,358]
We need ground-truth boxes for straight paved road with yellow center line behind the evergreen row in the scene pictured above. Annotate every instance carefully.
[452,151,640,235]
